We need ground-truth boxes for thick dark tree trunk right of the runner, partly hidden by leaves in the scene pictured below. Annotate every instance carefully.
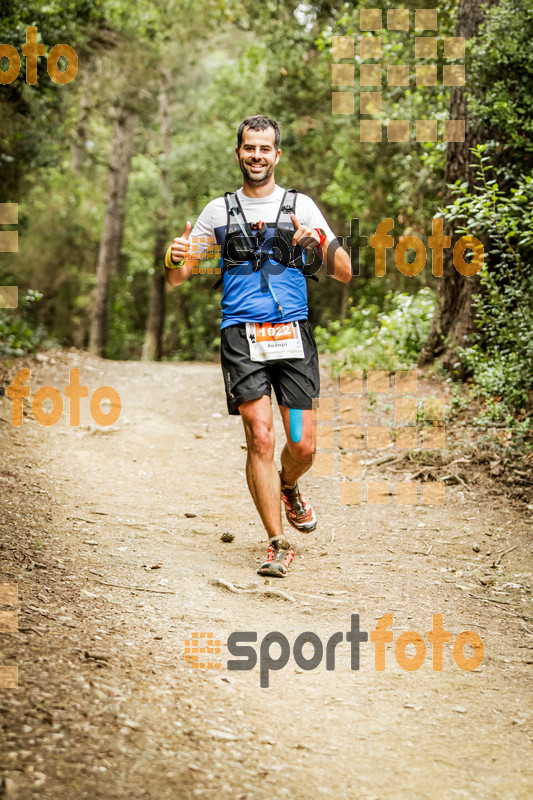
[418,0,495,369]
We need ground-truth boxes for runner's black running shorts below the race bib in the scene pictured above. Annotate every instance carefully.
[220,319,320,414]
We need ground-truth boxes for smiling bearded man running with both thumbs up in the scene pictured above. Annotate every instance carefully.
[165,115,351,578]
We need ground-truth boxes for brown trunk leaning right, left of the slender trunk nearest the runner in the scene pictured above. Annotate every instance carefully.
[89,108,137,356]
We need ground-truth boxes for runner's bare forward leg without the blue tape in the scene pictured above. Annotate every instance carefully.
[239,395,283,539]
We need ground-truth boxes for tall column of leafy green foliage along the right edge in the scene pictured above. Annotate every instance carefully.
[434,0,533,452]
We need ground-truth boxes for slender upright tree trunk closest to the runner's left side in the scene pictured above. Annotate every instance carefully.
[142,64,172,361]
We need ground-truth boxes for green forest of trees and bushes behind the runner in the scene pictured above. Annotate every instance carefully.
[0,0,533,450]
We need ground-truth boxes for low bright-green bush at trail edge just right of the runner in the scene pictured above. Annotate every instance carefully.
[315,288,434,370]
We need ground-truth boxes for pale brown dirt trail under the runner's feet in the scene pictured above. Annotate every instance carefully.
[0,353,533,800]
